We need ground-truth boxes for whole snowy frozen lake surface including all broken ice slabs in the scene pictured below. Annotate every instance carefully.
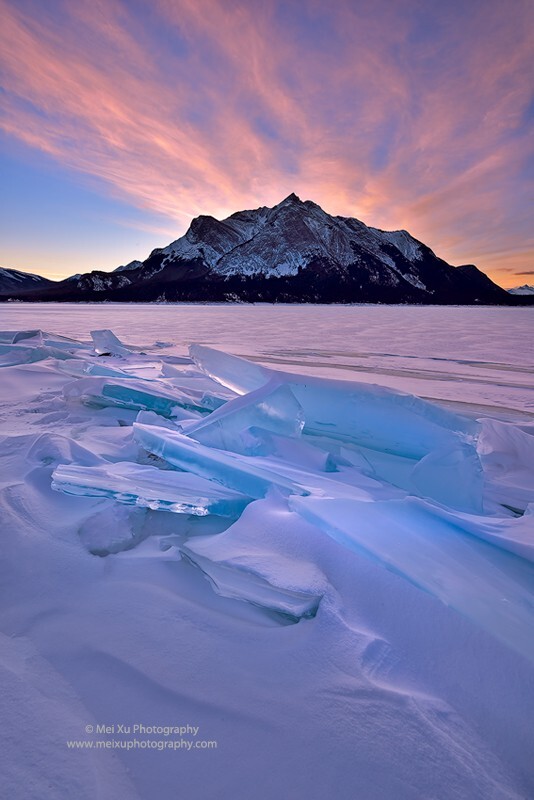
[0,304,534,800]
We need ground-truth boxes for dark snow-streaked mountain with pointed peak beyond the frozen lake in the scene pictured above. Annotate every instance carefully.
[4,194,513,304]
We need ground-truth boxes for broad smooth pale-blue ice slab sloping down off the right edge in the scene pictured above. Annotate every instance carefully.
[289,497,534,660]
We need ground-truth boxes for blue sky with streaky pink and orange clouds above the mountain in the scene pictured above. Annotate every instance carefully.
[0,0,534,287]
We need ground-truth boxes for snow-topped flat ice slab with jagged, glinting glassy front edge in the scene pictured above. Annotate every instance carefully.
[52,462,251,517]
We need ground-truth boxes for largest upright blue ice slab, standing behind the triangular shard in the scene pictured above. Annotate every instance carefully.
[190,345,478,458]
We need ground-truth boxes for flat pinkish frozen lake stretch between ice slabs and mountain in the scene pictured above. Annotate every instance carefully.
[0,303,534,419]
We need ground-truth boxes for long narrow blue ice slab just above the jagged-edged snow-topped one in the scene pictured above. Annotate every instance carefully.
[133,423,308,497]
